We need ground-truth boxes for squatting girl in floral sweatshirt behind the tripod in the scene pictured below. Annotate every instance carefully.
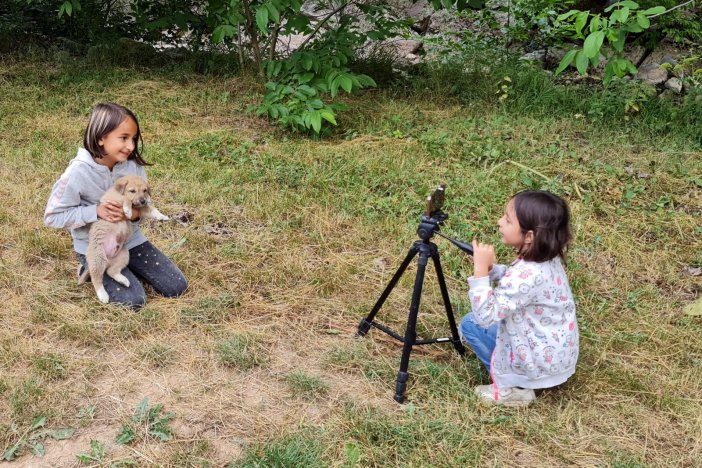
[460,191,578,406]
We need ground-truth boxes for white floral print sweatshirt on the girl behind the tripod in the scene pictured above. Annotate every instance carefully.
[468,257,579,388]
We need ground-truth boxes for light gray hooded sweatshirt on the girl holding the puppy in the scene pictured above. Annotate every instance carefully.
[44,148,146,255]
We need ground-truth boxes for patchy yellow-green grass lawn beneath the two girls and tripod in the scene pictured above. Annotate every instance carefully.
[0,46,702,466]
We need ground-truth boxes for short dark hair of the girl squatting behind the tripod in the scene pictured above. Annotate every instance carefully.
[512,190,571,262]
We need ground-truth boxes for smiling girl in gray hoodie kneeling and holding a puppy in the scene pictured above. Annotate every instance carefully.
[44,103,188,309]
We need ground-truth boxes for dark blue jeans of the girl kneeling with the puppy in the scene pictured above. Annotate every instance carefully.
[78,241,188,309]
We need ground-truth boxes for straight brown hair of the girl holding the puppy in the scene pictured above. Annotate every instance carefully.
[83,102,151,166]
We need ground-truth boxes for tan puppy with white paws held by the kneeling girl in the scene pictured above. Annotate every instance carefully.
[78,175,168,304]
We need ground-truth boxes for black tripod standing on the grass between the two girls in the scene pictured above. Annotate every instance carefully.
[357,210,473,403]
